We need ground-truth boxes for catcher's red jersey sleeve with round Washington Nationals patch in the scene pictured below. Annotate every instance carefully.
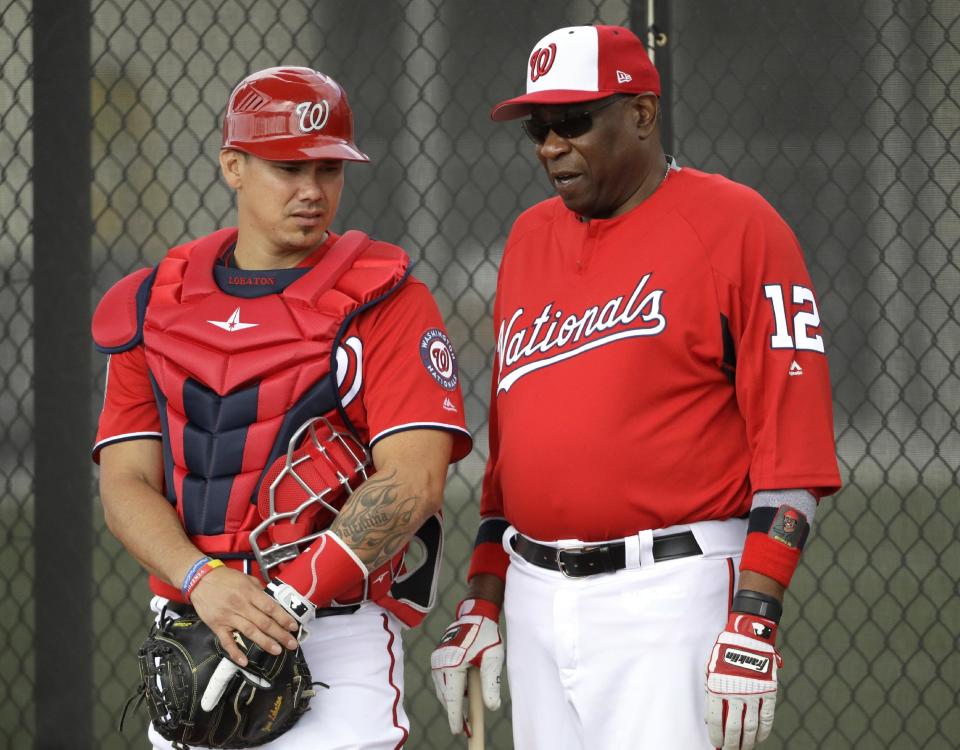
[348,278,473,461]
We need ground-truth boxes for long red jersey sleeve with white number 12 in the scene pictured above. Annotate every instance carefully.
[720,200,840,496]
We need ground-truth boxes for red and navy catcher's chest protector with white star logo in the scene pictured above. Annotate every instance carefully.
[95,229,409,553]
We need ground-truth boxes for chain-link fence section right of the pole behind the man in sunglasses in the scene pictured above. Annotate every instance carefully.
[671,0,960,749]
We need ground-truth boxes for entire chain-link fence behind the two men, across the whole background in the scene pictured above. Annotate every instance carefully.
[0,0,960,750]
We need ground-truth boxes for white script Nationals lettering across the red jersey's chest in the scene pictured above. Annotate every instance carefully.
[497,273,667,393]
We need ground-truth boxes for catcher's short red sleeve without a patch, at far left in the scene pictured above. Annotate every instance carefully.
[93,346,162,463]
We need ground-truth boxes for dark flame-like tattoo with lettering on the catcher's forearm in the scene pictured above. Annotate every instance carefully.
[330,471,423,570]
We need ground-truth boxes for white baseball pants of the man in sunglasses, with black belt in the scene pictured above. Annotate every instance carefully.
[503,519,746,750]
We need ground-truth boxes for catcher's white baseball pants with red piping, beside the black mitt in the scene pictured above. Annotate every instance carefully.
[149,599,410,750]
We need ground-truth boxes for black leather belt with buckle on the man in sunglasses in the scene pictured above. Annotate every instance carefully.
[510,531,703,578]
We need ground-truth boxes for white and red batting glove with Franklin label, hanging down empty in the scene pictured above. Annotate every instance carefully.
[706,612,783,750]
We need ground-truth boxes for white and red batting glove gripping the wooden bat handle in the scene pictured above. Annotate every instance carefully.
[430,599,504,734]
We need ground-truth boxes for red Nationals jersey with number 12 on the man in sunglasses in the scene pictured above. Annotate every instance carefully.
[481,164,840,541]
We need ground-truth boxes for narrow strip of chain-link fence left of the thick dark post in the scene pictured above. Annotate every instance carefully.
[0,2,35,748]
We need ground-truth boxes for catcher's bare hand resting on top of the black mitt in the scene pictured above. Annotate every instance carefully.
[190,567,299,667]
